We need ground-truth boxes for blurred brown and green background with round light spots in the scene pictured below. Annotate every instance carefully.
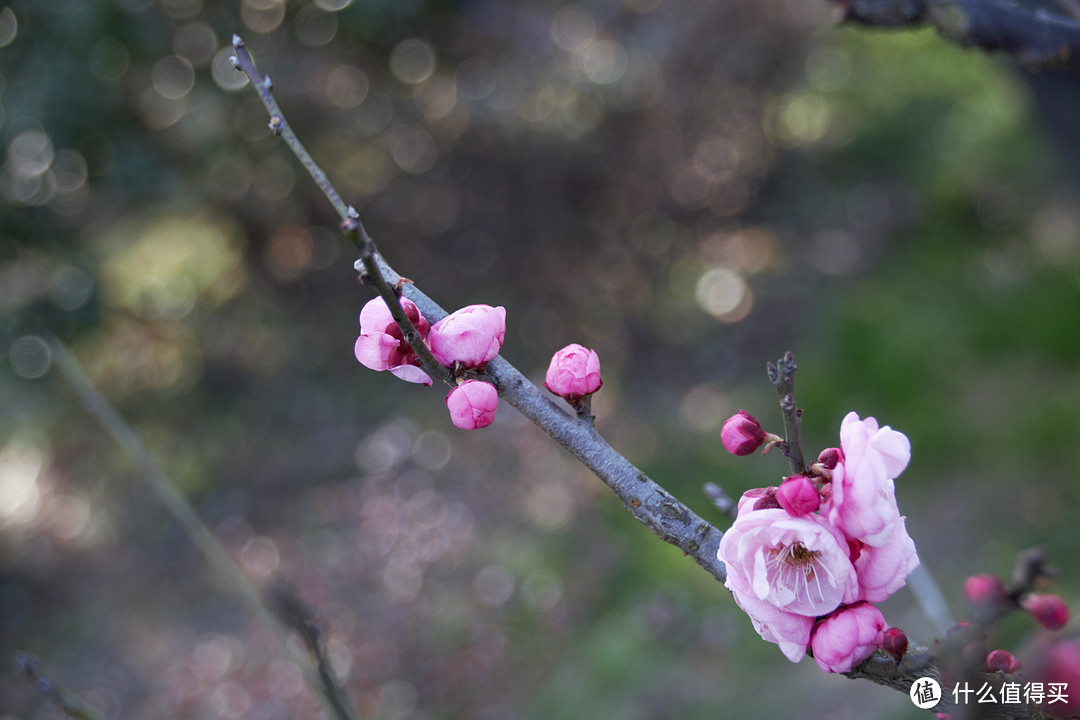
[0,0,1080,720]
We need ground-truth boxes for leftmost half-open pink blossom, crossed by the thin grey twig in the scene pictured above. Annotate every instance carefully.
[353,298,431,385]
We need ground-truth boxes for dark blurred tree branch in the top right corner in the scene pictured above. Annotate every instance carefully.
[832,0,1080,70]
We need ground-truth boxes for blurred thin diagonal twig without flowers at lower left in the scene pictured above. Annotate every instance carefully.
[49,338,356,720]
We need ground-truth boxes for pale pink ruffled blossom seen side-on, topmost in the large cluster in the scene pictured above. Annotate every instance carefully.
[827,412,912,546]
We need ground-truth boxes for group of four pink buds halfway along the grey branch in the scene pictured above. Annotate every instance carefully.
[354,298,604,430]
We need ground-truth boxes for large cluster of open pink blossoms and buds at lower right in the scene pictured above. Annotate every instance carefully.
[717,410,919,673]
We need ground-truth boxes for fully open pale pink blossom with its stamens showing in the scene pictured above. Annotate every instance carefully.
[717,503,859,626]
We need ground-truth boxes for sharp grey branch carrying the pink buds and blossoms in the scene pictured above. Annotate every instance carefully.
[233,36,727,582]
